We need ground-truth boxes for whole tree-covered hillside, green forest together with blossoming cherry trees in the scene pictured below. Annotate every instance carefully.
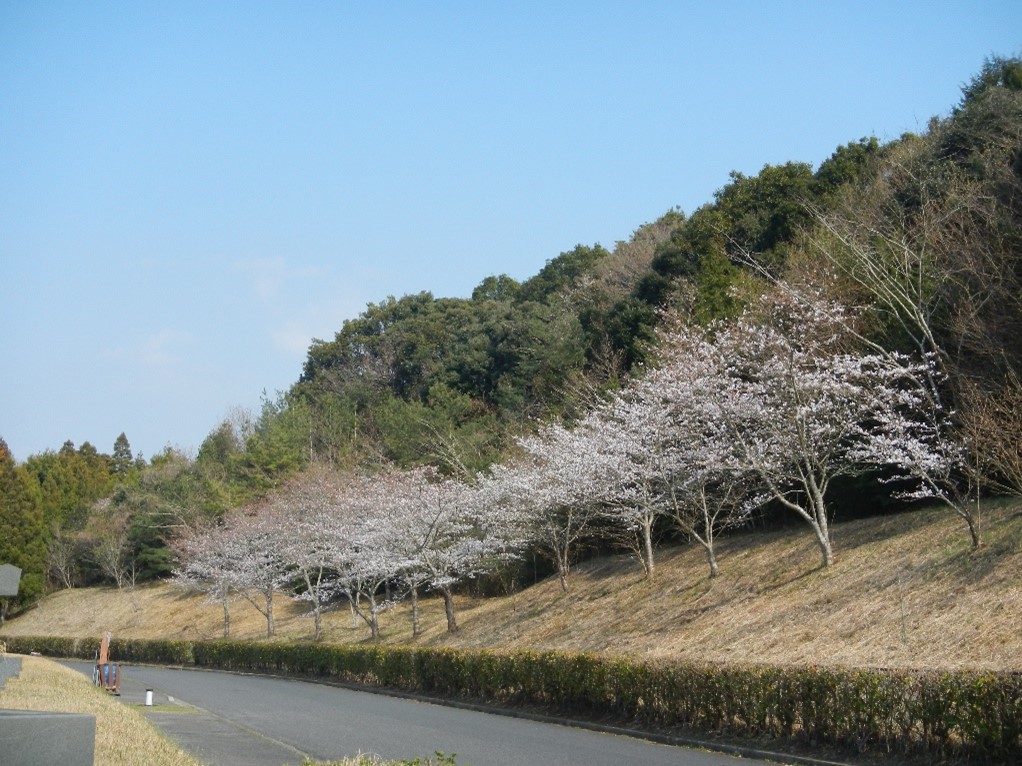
[0,57,1022,636]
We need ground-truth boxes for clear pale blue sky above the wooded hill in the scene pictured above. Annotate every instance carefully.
[0,0,1022,461]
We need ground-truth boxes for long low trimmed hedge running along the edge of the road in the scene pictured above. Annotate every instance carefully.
[7,637,1022,763]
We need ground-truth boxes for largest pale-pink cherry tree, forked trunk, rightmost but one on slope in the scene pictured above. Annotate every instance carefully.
[679,294,946,566]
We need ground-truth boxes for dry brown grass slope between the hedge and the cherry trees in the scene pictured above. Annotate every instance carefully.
[0,500,1022,670]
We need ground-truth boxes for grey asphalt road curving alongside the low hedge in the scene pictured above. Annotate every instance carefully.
[66,662,780,766]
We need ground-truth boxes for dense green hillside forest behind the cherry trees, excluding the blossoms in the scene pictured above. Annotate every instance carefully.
[0,57,1022,611]
